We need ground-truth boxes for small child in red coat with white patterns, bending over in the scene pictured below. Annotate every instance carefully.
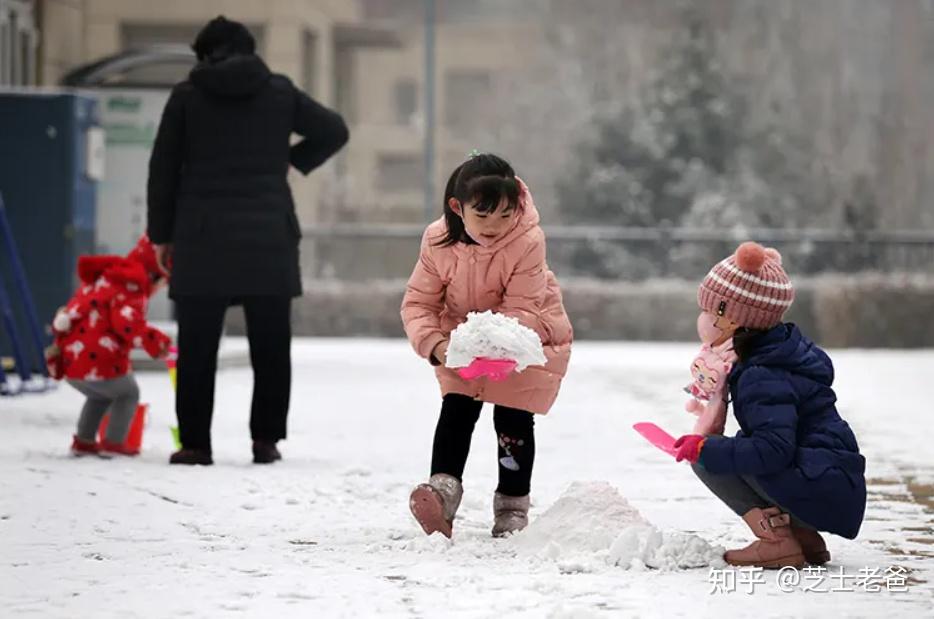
[46,235,171,455]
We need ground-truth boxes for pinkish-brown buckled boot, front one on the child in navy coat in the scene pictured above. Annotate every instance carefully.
[723,507,804,569]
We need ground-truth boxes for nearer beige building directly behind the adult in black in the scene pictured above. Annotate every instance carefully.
[31,0,373,228]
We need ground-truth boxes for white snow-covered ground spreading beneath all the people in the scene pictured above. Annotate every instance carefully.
[0,340,934,619]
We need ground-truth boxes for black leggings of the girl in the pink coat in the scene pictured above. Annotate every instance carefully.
[431,393,535,496]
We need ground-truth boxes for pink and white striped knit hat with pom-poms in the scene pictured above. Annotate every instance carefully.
[697,242,795,329]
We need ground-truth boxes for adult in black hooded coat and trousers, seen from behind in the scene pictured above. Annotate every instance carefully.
[148,17,348,464]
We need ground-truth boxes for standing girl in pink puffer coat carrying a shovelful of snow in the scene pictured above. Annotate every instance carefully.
[402,154,573,537]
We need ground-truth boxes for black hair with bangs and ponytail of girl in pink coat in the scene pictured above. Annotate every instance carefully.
[435,153,519,247]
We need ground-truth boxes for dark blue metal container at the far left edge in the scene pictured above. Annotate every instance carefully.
[0,90,104,366]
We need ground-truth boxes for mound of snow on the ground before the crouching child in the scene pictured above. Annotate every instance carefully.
[513,482,724,572]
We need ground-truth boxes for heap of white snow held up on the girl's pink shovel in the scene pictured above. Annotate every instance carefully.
[446,310,547,372]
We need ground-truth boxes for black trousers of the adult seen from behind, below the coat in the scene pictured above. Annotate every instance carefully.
[175,296,292,450]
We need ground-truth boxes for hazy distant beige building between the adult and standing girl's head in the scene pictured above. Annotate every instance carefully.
[329,1,543,223]
